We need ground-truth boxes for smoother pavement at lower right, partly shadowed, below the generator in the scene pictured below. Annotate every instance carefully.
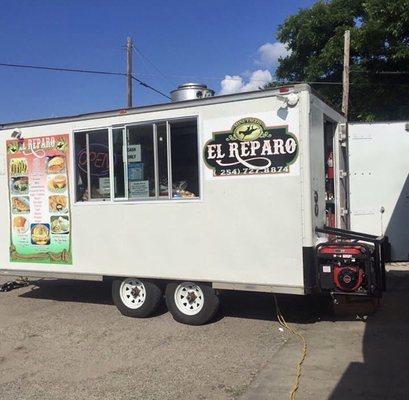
[241,264,409,400]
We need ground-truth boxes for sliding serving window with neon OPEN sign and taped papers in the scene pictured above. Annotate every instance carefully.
[74,119,200,202]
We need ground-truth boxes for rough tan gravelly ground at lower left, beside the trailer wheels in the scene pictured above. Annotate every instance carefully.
[0,278,286,400]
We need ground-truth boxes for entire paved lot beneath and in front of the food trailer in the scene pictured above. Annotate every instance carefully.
[0,265,409,400]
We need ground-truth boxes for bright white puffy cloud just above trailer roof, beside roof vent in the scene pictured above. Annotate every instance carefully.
[220,69,273,94]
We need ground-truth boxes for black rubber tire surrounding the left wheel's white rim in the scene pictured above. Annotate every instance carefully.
[112,278,163,318]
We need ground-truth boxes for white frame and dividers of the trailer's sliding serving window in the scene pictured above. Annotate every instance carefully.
[72,115,203,205]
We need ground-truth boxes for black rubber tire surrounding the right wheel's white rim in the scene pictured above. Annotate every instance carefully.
[165,282,219,325]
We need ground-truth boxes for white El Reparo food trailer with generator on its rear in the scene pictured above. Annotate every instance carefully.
[0,85,385,324]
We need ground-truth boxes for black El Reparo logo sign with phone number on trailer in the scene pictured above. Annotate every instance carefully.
[204,118,298,176]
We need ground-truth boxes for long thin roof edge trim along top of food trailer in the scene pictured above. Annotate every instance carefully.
[0,84,338,130]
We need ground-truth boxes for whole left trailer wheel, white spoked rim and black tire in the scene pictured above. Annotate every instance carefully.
[112,278,162,318]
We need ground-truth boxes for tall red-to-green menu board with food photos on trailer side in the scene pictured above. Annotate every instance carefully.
[6,135,72,264]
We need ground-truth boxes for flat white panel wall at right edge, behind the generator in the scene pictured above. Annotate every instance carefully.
[349,122,409,261]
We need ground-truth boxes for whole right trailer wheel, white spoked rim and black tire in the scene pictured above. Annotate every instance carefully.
[165,282,219,325]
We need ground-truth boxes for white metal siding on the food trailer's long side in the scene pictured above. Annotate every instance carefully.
[0,92,311,287]
